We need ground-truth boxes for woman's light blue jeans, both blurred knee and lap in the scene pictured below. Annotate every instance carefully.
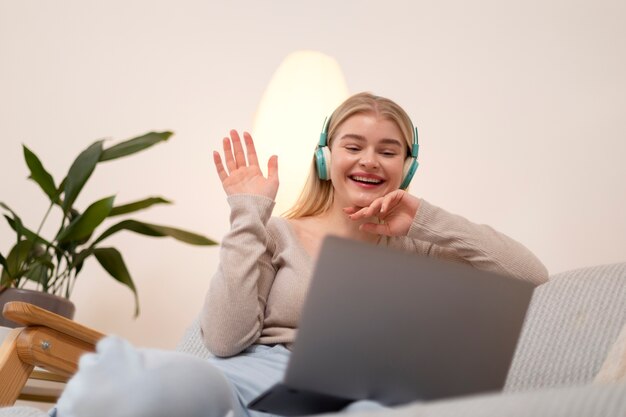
[50,336,382,417]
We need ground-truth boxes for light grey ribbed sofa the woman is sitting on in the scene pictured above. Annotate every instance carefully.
[0,262,626,417]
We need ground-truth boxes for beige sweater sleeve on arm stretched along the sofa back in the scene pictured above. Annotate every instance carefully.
[408,200,548,284]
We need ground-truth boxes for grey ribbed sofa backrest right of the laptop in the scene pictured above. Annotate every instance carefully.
[506,263,626,390]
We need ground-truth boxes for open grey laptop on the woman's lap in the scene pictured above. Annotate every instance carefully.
[248,237,534,416]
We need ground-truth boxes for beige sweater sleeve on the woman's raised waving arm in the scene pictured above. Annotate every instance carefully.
[200,195,275,356]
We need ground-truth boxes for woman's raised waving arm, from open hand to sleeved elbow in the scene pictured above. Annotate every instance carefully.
[200,130,278,356]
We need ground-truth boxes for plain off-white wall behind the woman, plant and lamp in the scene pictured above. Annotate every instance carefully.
[0,0,626,348]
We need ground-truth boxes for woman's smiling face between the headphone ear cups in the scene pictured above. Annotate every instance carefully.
[330,113,407,207]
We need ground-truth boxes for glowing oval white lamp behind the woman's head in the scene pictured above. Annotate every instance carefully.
[252,51,348,214]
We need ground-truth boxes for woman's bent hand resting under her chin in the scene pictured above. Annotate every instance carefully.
[343,190,420,236]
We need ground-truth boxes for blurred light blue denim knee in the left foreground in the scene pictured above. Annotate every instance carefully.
[52,336,236,417]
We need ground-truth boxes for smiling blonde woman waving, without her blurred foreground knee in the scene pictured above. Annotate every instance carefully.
[201,93,548,415]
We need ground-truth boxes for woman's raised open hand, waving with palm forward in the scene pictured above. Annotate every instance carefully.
[213,130,278,200]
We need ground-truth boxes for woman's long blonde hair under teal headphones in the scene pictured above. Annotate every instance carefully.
[283,92,413,219]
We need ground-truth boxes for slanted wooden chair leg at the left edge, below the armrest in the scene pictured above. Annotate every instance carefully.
[0,328,33,407]
